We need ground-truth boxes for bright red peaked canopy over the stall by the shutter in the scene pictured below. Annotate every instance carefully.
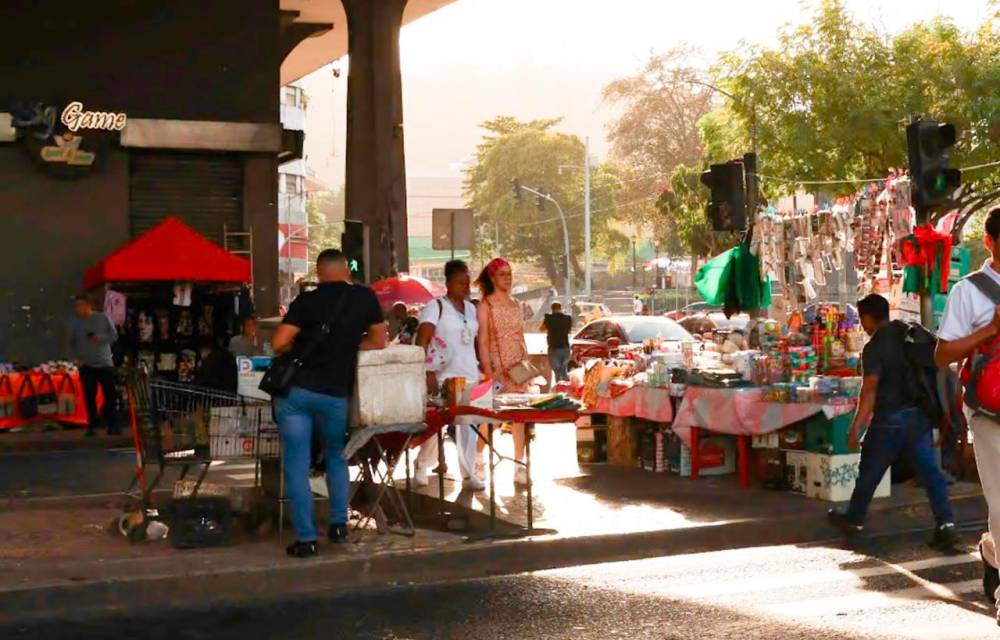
[83,217,251,289]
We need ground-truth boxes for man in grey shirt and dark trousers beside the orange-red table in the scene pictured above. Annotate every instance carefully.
[69,295,120,436]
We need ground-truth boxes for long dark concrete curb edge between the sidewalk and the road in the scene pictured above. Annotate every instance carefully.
[0,496,986,625]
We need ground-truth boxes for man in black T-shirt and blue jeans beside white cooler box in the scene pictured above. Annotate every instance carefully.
[271,249,387,558]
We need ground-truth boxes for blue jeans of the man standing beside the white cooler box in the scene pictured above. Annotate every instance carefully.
[275,387,350,542]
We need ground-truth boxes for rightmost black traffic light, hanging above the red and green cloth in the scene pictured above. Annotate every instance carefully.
[906,119,962,221]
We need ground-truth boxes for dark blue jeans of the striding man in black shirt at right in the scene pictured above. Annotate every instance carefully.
[847,408,955,525]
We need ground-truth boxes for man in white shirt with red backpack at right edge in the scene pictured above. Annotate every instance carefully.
[935,208,1000,616]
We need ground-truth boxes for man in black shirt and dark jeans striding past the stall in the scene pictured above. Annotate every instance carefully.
[829,294,959,551]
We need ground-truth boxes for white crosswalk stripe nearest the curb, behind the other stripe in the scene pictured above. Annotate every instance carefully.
[669,553,979,598]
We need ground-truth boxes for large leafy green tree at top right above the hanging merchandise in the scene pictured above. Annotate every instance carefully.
[716,0,1000,195]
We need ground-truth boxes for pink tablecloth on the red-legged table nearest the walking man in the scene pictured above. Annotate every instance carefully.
[673,387,854,445]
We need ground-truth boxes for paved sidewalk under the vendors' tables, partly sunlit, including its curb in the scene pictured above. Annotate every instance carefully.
[0,427,986,621]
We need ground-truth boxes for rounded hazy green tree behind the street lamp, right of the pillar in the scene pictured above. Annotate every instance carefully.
[465,116,629,285]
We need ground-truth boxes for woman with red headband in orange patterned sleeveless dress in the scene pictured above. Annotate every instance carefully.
[476,258,530,485]
